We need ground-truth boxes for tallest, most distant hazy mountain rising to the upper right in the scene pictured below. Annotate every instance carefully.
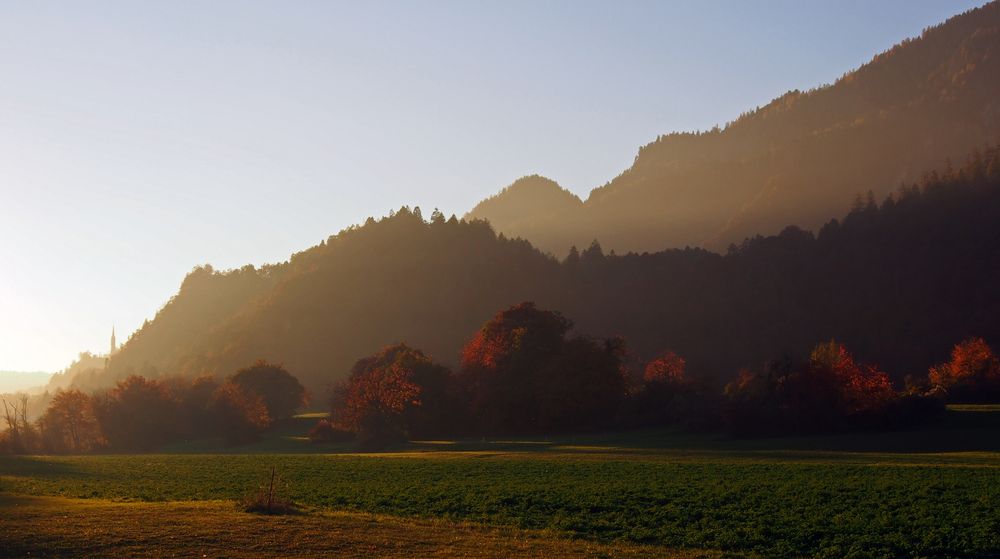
[466,2,1000,255]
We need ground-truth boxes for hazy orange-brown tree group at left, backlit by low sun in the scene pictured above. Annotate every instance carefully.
[0,361,308,453]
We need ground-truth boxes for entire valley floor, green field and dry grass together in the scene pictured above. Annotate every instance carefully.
[0,406,1000,558]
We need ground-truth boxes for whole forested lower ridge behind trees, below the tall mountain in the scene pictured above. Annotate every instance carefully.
[72,148,1000,395]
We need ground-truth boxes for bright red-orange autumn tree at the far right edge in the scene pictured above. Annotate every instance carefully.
[928,338,1000,402]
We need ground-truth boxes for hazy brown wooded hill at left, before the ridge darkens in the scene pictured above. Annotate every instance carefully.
[95,213,559,390]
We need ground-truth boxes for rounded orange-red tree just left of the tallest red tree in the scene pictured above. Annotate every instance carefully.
[331,344,456,444]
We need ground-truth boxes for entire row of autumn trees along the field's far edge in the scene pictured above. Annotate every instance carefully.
[2,302,1000,452]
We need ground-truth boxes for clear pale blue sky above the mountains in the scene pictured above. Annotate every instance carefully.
[0,0,982,371]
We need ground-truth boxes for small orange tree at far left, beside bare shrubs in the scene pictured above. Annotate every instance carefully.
[38,390,104,452]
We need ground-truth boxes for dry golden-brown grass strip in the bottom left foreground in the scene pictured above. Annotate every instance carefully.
[0,494,717,558]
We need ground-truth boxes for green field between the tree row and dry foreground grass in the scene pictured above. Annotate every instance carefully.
[0,408,1000,557]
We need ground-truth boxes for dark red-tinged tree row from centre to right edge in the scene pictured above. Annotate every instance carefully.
[311,302,1000,447]
